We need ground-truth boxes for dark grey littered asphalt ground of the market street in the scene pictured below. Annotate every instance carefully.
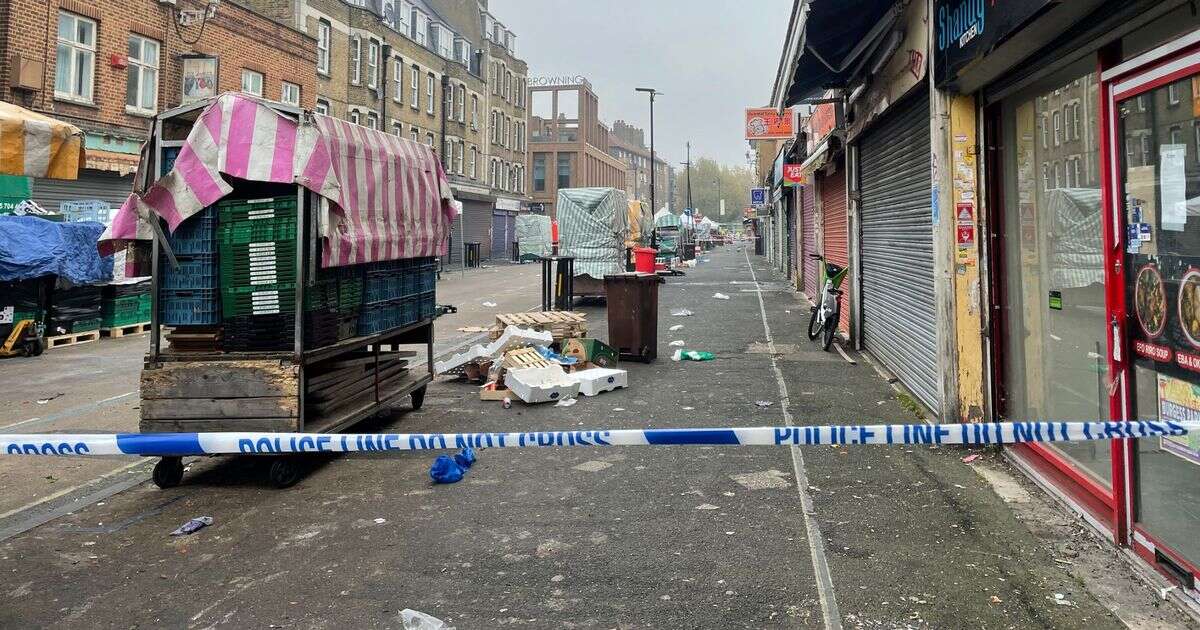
[0,246,1190,629]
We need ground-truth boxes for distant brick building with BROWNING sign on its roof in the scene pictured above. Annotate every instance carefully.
[528,77,626,216]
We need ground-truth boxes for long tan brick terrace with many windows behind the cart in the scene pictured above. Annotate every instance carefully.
[245,0,524,262]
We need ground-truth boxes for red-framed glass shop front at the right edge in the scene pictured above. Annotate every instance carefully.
[955,1,1200,598]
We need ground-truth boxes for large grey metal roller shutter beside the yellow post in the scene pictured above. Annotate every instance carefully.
[859,90,941,412]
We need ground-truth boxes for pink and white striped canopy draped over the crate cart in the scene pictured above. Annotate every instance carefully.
[101,94,457,266]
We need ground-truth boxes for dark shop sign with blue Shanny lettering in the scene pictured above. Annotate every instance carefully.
[934,0,1055,88]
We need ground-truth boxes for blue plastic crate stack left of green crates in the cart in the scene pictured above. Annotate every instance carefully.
[158,208,221,326]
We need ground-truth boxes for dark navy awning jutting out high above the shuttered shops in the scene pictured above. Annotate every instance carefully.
[774,0,900,107]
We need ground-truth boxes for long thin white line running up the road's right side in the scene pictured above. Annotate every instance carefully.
[743,251,841,630]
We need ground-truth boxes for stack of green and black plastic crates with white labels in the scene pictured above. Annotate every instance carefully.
[217,197,299,350]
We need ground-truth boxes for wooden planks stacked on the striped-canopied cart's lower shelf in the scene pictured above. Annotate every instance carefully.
[305,350,416,415]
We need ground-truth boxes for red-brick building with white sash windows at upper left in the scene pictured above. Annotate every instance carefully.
[0,0,316,210]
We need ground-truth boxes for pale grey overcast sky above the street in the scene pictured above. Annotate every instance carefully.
[488,0,792,166]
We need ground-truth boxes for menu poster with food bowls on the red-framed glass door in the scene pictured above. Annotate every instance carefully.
[1126,254,1200,380]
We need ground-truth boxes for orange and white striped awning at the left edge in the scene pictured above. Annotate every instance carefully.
[0,101,84,179]
